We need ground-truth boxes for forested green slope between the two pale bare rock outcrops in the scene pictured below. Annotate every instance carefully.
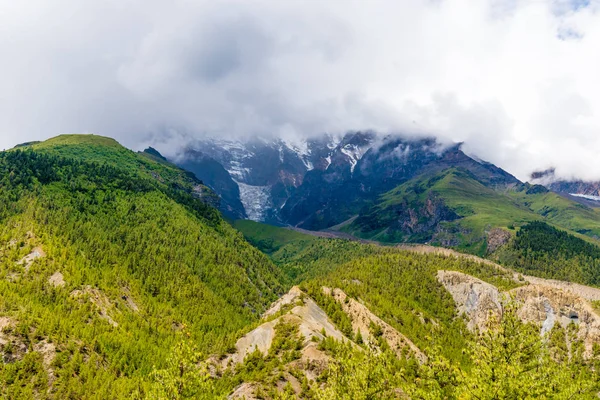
[239,223,518,362]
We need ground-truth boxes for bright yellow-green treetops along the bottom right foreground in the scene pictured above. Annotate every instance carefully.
[314,308,599,400]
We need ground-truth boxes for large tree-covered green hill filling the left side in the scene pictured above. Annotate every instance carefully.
[0,135,284,399]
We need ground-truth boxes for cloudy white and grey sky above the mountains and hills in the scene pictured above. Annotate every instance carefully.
[0,0,600,180]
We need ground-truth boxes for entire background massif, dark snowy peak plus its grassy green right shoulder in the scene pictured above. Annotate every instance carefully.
[169,132,600,255]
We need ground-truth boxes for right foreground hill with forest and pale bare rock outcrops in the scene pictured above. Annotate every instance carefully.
[229,223,600,399]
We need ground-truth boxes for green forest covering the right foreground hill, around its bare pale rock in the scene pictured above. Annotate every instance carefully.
[232,223,599,399]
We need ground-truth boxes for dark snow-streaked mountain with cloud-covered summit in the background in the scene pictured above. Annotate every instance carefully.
[171,132,519,225]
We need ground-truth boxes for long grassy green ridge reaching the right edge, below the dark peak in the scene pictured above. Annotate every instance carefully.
[350,168,600,255]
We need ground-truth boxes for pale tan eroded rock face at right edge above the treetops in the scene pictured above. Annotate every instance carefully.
[438,271,600,357]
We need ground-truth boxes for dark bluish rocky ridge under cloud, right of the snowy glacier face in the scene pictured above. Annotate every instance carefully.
[281,137,521,230]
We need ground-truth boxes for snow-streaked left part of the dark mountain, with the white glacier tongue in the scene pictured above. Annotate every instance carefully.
[170,133,374,223]
